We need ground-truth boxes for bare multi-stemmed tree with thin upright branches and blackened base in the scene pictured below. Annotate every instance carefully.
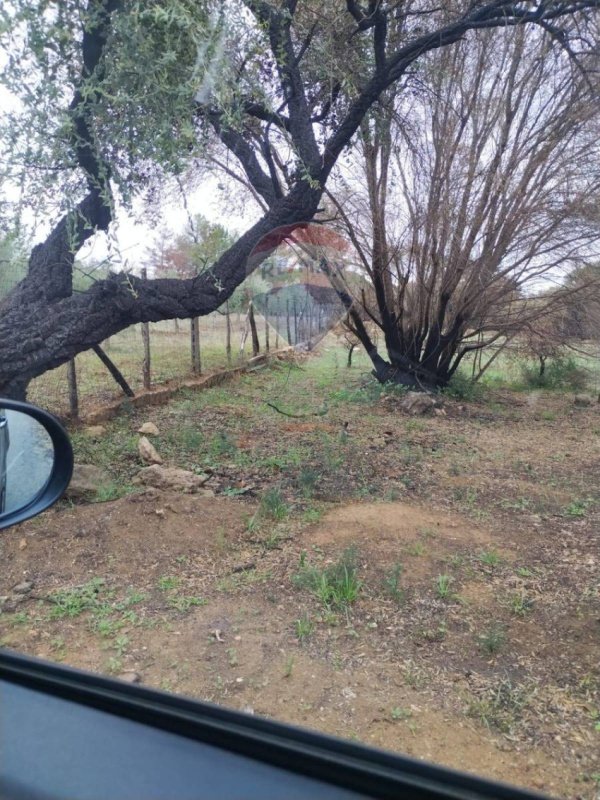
[330,29,600,387]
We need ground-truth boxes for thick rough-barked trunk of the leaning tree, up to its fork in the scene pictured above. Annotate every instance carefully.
[0,184,321,399]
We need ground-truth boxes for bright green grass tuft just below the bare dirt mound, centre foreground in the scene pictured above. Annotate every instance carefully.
[293,547,363,608]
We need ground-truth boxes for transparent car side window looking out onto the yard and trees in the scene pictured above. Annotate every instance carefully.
[0,6,600,800]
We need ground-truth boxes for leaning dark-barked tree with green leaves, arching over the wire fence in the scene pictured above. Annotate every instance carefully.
[0,0,600,396]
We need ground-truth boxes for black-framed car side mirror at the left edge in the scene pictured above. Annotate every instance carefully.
[0,398,73,530]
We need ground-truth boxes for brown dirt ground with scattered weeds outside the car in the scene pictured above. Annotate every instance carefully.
[0,351,600,800]
